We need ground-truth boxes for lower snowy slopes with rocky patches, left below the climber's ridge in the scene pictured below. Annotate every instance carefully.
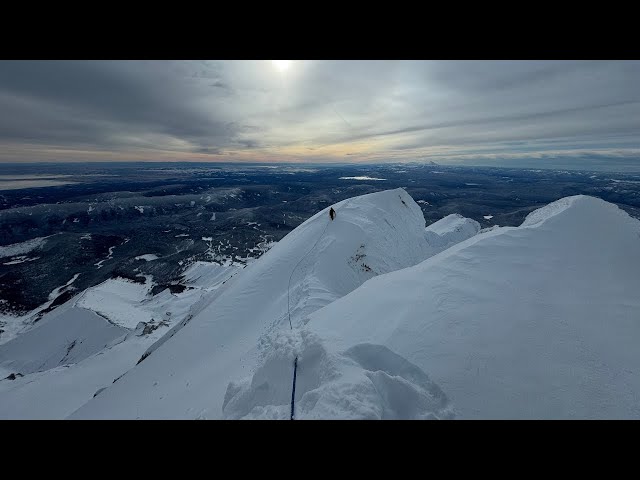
[0,262,238,419]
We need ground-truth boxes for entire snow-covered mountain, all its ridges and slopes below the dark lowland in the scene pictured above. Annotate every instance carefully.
[0,189,640,419]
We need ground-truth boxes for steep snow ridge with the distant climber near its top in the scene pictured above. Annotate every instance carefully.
[72,189,464,418]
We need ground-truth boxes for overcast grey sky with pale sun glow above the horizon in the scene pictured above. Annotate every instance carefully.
[0,60,640,168]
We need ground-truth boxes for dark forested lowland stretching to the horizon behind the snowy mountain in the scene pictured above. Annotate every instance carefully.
[0,163,640,326]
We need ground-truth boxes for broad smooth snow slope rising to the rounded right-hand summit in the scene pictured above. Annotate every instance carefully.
[304,196,640,419]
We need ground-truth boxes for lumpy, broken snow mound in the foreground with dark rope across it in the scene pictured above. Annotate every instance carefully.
[223,329,453,420]
